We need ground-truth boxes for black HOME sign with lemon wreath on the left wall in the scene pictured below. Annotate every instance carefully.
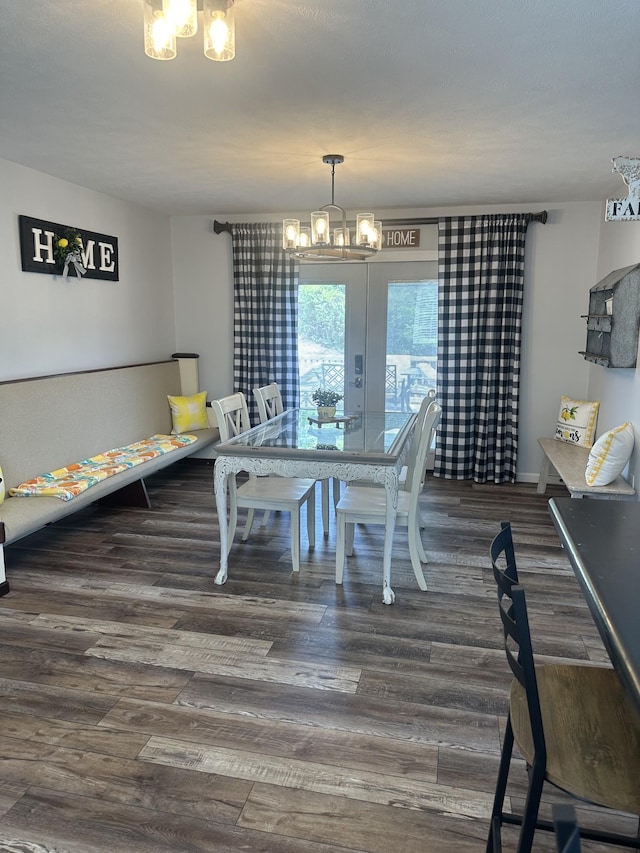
[18,216,119,281]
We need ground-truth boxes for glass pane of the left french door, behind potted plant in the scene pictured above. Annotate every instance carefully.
[298,283,345,409]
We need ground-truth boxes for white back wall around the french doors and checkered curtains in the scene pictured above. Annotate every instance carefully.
[171,202,601,481]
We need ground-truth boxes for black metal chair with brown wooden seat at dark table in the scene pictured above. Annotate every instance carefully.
[486,523,640,853]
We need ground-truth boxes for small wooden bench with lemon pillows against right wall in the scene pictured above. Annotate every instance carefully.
[538,438,636,499]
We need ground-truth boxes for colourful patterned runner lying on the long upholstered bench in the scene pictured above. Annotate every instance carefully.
[9,435,198,501]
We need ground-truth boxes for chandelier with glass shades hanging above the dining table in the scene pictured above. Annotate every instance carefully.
[282,154,382,261]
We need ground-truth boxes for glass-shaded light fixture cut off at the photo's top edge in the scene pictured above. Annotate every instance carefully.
[142,0,236,62]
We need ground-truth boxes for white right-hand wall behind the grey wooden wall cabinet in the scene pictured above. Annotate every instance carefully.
[592,213,640,489]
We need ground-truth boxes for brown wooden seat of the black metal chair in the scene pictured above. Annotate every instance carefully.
[510,665,640,814]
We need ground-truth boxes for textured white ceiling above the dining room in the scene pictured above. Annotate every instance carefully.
[0,0,640,215]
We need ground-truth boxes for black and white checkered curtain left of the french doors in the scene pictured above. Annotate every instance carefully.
[231,222,299,424]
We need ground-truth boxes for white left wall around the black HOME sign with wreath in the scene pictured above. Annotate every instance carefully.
[0,160,175,380]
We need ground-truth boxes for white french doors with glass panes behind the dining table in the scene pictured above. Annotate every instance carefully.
[298,261,438,411]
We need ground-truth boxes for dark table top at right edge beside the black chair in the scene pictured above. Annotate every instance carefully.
[549,498,640,710]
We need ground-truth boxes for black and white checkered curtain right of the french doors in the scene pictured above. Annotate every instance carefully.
[434,213,532,483]
